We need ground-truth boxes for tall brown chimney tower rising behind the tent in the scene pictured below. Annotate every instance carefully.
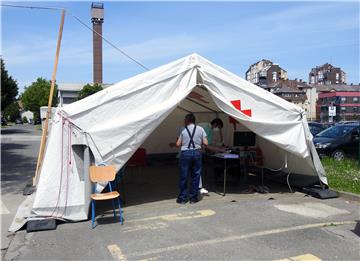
[91,3,104,83]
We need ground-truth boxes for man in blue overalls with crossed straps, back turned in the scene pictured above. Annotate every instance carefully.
[176,114,208,204]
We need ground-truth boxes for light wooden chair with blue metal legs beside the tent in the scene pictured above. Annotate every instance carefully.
[89,166,123,228]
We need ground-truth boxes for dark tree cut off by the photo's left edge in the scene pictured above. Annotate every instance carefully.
[0,58,19,112]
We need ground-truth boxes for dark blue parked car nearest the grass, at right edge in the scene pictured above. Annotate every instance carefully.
[313,122,360,160]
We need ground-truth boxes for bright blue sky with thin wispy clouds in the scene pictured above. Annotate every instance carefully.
[1,1,360,92]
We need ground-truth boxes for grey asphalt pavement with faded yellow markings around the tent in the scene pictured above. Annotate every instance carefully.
[1,126,360,260]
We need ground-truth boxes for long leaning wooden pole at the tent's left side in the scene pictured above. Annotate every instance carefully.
[33,9,65,186]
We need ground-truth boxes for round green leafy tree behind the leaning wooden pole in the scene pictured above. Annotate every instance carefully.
[21,78,58,120]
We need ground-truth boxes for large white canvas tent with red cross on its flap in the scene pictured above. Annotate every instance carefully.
[11,54,327,225]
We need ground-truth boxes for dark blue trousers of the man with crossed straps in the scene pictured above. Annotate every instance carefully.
[178,150,202,201]
